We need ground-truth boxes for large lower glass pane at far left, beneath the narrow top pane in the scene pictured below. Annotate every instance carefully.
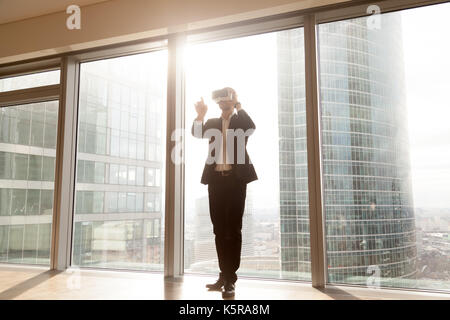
[0,101,58,265]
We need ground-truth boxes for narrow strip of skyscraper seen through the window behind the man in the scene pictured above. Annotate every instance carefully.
[277,29,311,280]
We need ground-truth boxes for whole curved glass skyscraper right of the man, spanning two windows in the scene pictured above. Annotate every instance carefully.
[278,15,416,284]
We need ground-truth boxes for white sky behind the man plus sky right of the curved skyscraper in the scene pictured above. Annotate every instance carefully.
[185,3,450,215]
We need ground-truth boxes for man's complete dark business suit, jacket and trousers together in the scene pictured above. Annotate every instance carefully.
[192,109,258,283]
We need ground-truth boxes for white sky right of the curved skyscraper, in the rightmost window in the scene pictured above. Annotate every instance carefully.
[402,3,450,208]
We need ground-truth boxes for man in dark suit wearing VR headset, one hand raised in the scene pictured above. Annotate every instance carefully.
[192,88,258,298]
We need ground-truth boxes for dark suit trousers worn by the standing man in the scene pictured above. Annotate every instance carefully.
[208,172,247,283]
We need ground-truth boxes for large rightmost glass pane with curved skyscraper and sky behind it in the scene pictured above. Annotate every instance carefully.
[318,4,450,290]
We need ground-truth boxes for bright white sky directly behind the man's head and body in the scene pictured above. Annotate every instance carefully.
[185,33,279,215]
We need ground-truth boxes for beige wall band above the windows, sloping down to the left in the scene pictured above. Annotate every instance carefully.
[0,0,350,64]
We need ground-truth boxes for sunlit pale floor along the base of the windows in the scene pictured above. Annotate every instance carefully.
[0,265,450,300]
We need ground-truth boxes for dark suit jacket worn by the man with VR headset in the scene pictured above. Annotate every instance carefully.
[191,109,258,184]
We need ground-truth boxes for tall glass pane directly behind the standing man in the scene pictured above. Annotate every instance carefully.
[183,28,311,280]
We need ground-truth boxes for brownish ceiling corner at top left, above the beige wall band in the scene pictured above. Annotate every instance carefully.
[0,0,108,24]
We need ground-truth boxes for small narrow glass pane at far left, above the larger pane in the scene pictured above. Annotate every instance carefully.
[0,70,60,92]
